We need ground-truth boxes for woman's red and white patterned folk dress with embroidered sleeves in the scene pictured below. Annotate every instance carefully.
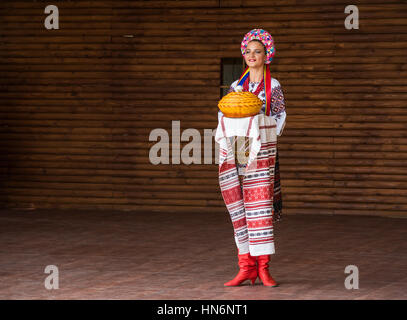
[219,78,286,256]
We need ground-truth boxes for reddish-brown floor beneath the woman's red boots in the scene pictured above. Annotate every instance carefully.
[0,210,407,300]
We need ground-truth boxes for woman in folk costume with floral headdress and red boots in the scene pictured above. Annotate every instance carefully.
[219,29,286,287]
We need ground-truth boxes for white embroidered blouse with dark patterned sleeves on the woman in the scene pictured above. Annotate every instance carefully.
[218,78,287,136]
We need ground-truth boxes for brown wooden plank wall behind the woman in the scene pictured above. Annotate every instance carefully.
[0,0,407,216]
